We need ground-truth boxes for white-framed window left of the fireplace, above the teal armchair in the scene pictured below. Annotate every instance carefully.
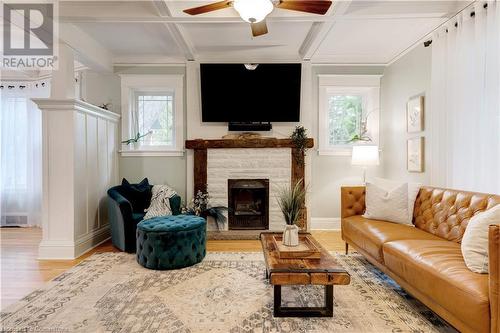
[121,74,184,156]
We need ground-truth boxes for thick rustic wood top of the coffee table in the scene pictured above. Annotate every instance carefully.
[260,232,351,285]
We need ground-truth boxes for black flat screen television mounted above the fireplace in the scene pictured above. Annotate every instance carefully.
[200,64,302,123]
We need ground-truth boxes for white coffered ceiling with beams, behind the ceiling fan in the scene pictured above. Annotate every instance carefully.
[12,0,471,69]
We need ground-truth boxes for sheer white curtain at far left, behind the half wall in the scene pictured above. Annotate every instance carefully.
[0,81,50,226]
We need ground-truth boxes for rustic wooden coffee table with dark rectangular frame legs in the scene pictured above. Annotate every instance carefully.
[260,232,351,317]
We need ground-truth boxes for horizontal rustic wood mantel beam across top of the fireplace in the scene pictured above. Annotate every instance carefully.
[186,138,314,149]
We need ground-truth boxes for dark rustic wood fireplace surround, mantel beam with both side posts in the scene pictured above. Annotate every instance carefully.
[186,138,314,229]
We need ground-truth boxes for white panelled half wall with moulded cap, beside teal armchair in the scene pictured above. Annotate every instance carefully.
[34,99,120,259]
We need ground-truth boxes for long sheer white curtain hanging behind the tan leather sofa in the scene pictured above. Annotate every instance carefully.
[428,1,500,193]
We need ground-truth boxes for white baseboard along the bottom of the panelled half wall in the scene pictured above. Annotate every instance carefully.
[38,225,110,260]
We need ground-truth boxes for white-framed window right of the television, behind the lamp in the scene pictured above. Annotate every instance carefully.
[318,75,380,155]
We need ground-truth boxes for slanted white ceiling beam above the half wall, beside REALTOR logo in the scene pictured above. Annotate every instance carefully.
[59,23,113,72]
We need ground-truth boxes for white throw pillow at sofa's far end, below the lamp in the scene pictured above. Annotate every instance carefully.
[363,183,408,224]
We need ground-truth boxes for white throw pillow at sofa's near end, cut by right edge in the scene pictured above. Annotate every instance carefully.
[462,205,500,273]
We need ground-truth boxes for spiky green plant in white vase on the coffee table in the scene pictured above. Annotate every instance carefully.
[278,179,306,246]
